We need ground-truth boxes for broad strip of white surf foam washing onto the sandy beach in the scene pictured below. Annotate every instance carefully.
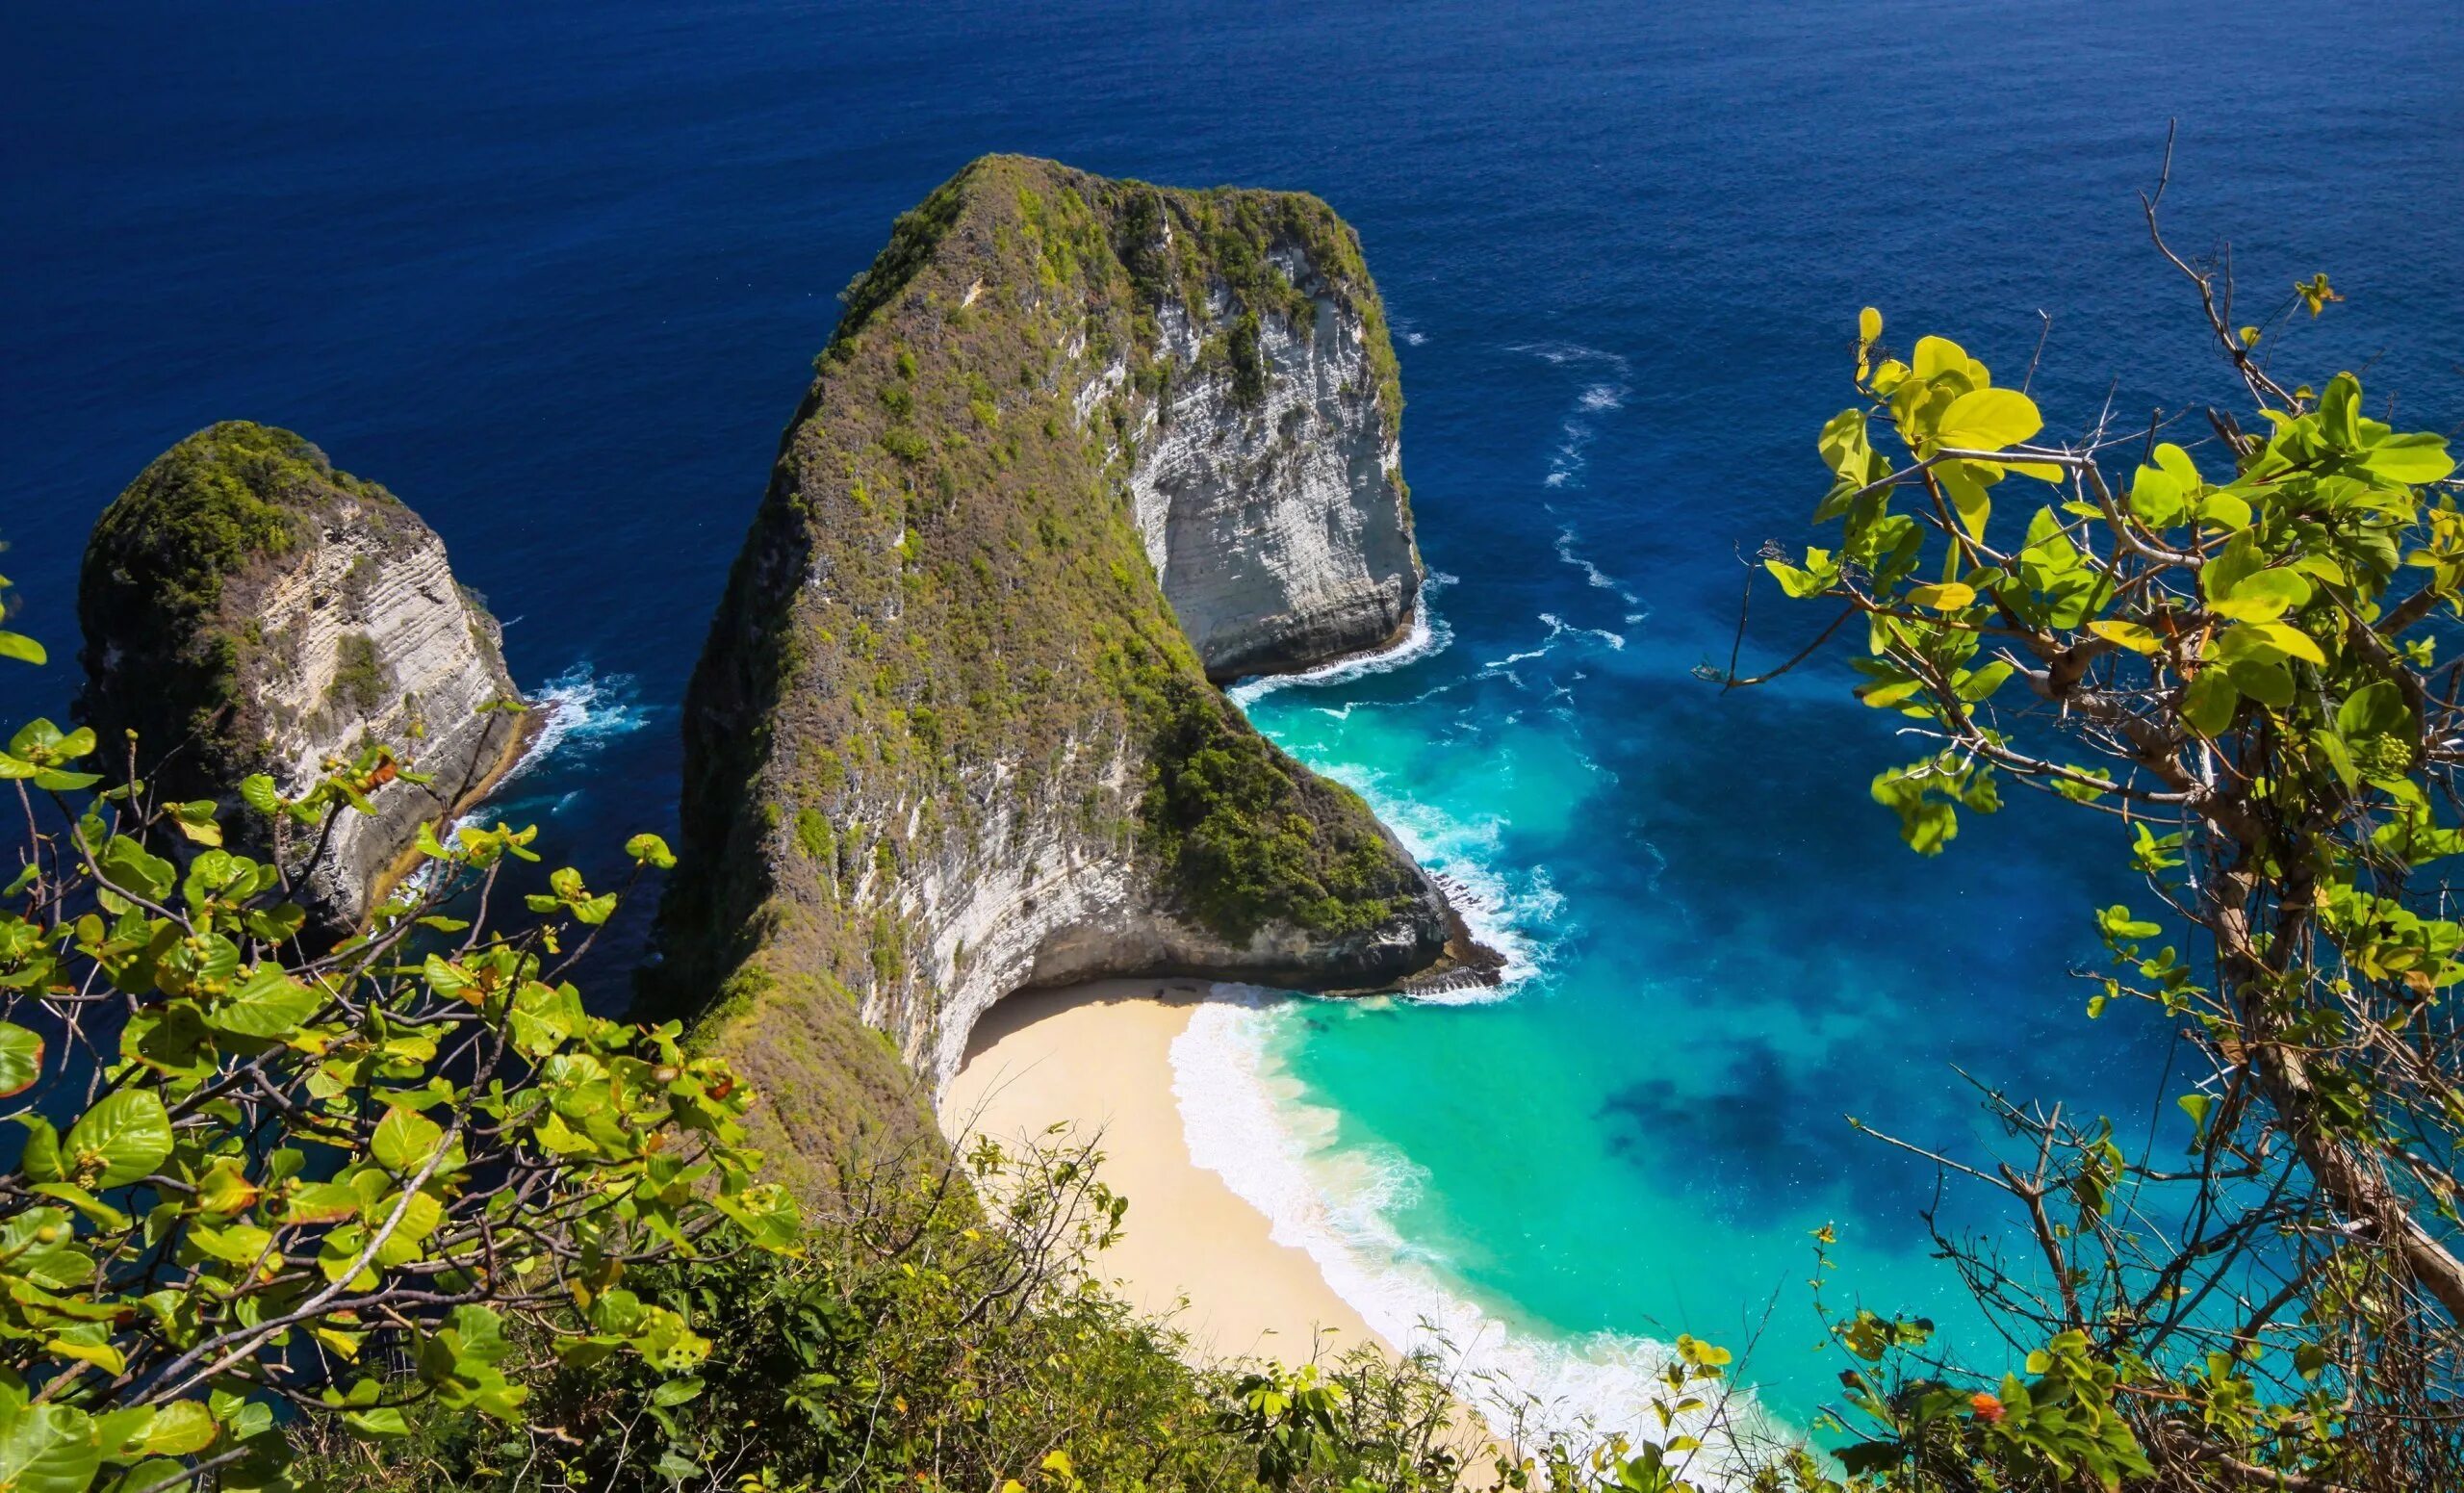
[1170,986,1761,1480]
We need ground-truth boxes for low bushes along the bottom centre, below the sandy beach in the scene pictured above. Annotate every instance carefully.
[293,1133,1784,1493]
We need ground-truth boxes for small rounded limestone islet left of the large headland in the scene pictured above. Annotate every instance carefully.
[76,422,520,934]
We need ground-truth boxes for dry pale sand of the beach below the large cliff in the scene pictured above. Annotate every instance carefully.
[941,981,1392,1362]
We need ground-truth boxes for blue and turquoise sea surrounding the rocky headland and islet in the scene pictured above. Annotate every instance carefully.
[0,0,2464,1448]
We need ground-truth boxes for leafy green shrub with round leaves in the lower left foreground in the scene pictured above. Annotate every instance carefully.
[0,581,793,1493]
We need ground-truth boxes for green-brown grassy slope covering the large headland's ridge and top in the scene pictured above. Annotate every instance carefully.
[648,158,1412,1197]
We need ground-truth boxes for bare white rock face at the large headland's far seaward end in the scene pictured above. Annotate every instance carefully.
[1131,249,1420,680]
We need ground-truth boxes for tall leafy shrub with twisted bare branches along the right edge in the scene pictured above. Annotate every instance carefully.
[1732,172,2464,1490]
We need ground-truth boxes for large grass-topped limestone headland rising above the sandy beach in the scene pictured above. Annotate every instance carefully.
[651,158,1471,1187]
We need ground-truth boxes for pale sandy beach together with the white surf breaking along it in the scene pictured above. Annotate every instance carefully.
[937,976,1796,1485]
